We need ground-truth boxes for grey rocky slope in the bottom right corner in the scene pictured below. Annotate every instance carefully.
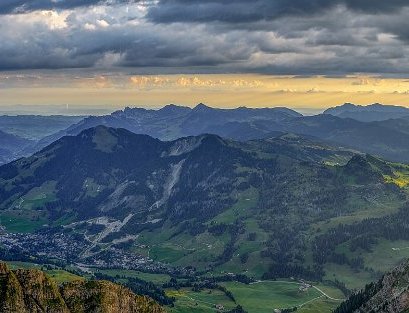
[335,261,409,313]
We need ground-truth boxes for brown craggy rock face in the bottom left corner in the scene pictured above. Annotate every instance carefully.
[0,263,165,313]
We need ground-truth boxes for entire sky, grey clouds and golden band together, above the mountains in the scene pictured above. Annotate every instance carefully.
[0,0,409,111]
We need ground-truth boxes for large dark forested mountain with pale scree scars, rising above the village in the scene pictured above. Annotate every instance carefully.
[0,126,409,279]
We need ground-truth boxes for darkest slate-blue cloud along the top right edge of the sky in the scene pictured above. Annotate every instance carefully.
[148,0,409,23]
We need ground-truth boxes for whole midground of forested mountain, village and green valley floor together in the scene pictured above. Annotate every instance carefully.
[0,126,409,313]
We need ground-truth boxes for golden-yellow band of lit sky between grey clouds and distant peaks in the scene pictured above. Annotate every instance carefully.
[0,74,409,109]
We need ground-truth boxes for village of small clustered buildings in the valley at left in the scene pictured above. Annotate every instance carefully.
[0,232,191,274]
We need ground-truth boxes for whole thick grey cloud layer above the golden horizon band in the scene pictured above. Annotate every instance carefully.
[0,0,409,75]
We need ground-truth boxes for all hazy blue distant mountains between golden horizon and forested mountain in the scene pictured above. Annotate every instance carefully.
[0,104,409,164]
